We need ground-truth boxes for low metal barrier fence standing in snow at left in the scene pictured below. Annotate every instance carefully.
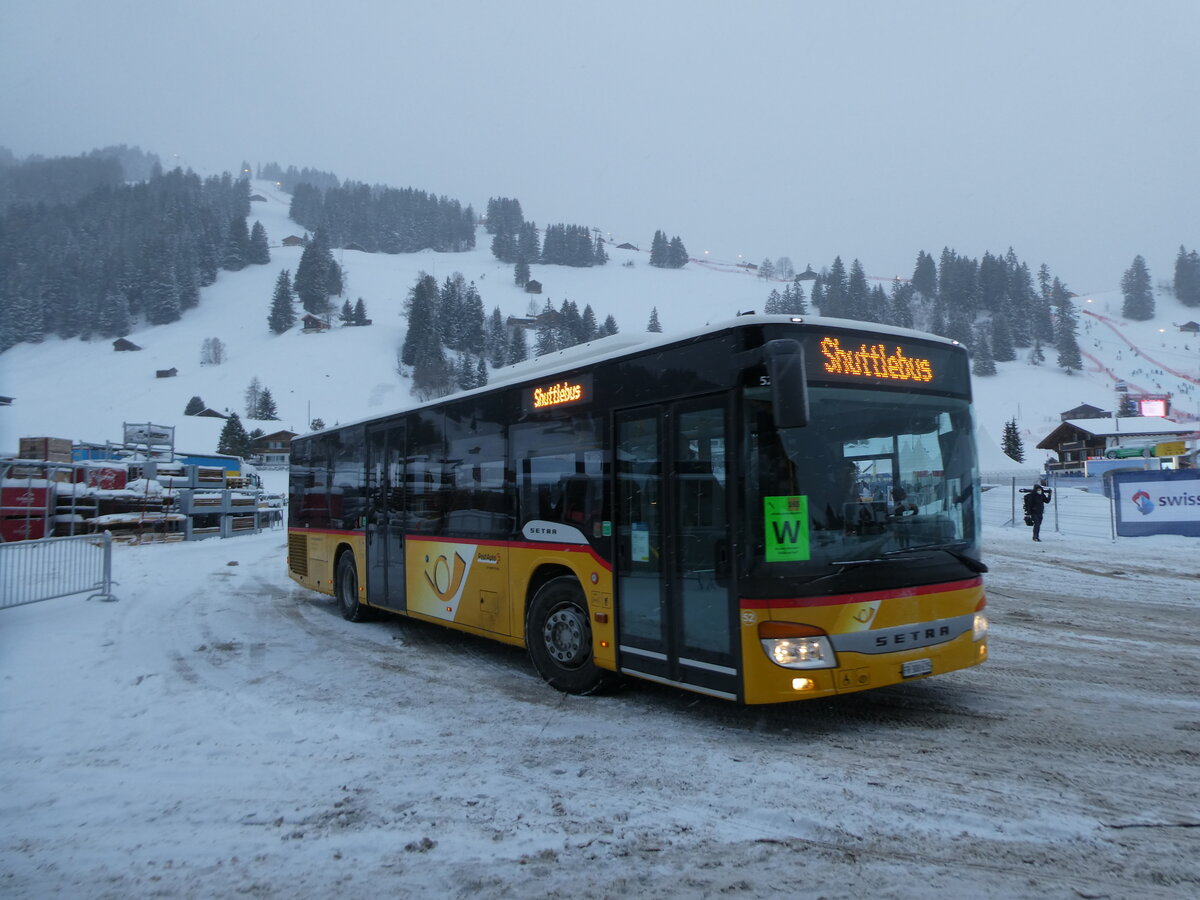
[0,532,116,610]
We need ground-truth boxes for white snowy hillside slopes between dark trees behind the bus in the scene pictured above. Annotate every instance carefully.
[0,181,1200,458]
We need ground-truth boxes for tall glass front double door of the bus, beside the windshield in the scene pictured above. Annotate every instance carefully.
[614,398,740,700]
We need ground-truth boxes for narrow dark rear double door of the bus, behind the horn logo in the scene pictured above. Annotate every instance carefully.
[367,422,406,611]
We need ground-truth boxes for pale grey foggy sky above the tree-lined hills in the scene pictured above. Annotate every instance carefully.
[0,0,1200,292]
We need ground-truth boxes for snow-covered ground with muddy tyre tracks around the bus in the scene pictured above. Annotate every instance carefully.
[0,487,1200,899]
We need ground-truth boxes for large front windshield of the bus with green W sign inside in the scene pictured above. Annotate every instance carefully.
[744,386,983,596]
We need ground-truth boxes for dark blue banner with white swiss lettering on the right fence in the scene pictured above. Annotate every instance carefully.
[1112,469,1200,538]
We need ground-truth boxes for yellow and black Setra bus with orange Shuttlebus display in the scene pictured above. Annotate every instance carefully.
[288,314,988,703]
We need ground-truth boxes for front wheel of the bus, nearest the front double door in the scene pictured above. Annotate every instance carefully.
[526,575,612,695]
